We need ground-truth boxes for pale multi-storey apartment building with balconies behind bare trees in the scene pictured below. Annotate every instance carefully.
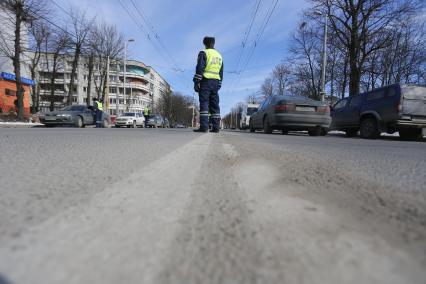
[37,54,171,116]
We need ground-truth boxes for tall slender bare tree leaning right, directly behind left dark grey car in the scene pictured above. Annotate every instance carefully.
[67,8,94,105]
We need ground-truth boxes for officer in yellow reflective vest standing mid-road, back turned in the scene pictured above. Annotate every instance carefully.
[193,37,223,132]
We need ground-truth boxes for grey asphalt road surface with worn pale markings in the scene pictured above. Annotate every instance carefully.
[0,128,426,284]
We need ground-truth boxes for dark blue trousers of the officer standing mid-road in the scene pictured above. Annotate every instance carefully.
[198,78,220,130]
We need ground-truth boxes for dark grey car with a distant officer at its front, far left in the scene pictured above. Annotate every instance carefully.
[39,105,111,127]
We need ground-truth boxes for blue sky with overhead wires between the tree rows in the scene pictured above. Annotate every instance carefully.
[55,0,308,115]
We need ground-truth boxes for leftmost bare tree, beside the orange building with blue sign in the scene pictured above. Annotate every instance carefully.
[0,0,45,120]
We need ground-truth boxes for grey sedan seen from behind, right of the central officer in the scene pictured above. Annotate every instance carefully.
[249,96,331,136]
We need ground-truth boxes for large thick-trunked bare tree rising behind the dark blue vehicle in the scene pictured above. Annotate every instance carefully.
[312,0,414,95]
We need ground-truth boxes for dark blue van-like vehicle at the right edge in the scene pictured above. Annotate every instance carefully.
[331,84,426,140]
